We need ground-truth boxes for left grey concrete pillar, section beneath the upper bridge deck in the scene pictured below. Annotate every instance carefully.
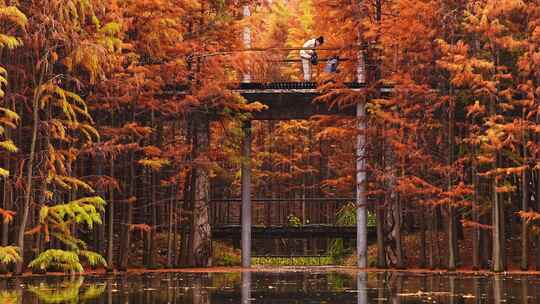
[241,121,251,268]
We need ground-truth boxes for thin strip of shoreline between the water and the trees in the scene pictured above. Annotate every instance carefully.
[0,266,540,279]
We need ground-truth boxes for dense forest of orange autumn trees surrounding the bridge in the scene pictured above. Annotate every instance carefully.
[0,0,540,274]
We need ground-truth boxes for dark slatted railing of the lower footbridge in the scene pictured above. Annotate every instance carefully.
[210,198,354,227]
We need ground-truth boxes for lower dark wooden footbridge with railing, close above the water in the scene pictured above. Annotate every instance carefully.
[210,198,375,240]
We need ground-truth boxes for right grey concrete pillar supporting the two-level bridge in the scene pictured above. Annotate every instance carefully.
[356,51,367,268]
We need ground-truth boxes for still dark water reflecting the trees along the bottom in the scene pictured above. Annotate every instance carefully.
[0,271,540,304]
